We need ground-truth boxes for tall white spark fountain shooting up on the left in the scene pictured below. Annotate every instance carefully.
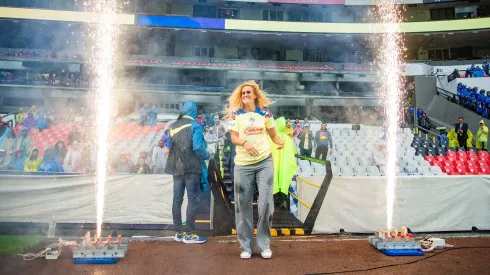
[85,0,118,237]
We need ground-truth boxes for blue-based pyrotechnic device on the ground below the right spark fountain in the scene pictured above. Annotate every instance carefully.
[369,227,424,256]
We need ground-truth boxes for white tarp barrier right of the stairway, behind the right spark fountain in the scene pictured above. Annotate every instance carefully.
[297,176,490,233]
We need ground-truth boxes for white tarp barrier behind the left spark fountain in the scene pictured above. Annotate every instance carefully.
[0,175,187,224]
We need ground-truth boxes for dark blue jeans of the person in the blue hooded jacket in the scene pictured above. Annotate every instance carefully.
[172,174,201,232]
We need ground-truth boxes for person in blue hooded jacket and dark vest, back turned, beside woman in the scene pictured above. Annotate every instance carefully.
[165,101,210,243]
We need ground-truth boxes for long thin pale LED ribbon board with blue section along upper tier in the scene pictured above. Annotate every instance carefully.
[0,6,490,34]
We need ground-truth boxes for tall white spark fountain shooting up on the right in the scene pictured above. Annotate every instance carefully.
[376,0,404,229]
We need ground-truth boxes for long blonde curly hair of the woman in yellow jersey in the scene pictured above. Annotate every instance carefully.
[225,80,274,120]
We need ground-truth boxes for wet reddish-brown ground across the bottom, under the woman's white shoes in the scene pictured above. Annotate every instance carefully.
[0,236,490,275]
